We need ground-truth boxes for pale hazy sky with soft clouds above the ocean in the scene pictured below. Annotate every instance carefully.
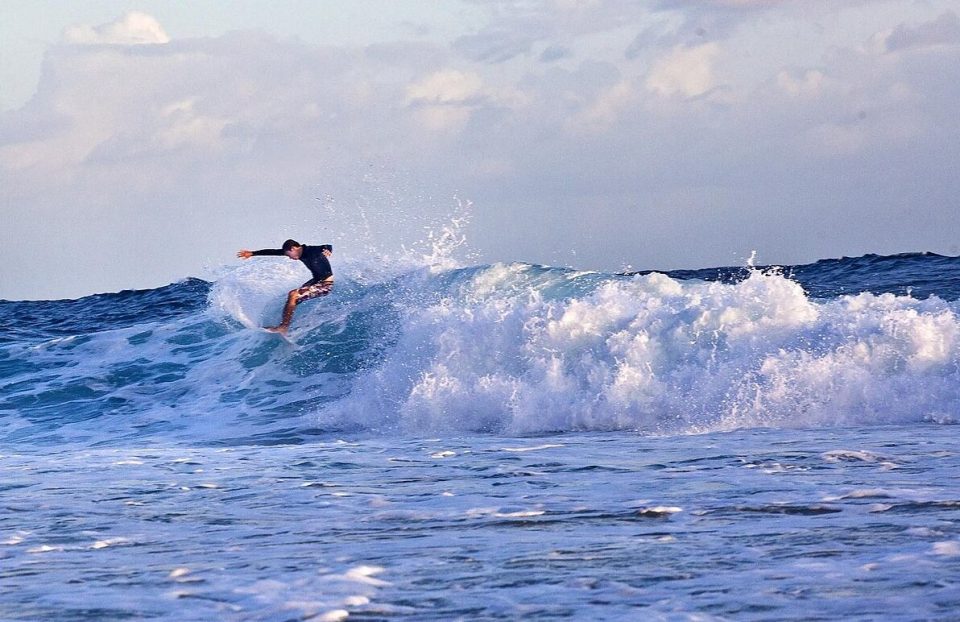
[0,0,960,300]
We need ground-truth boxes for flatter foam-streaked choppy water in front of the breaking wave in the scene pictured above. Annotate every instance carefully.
[0,432,960,620]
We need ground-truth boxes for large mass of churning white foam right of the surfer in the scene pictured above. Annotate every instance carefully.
[317,264,960,433]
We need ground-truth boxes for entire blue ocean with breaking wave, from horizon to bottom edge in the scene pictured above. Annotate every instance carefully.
[0,254,960,620]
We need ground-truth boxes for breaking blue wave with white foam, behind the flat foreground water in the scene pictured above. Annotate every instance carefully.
[0,255,960,448]
